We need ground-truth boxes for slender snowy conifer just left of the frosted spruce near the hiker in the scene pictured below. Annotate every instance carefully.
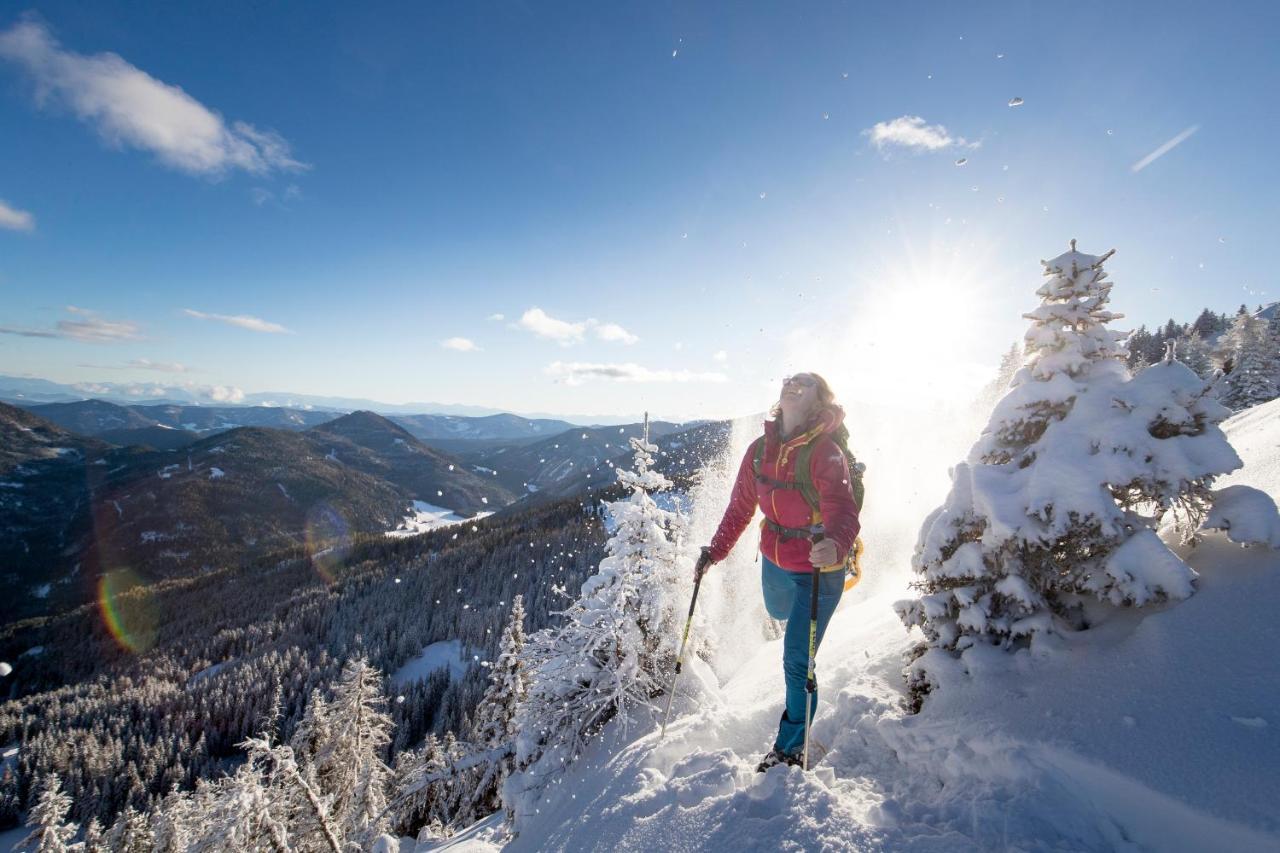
[456,596,529,826]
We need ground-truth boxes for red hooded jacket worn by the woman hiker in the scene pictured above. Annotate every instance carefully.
[712,406,860,574]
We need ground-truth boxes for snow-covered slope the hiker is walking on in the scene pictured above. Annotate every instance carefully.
[432,401,1280,852]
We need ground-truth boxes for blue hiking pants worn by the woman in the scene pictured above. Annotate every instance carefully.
[760,556,845,754]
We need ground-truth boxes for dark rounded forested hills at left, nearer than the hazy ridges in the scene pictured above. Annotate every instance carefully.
[0,403,515,617]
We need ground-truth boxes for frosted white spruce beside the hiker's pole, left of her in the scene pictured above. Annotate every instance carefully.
[502,416,685,824]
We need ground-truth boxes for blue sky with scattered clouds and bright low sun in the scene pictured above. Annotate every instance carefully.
[0,3,1280,418]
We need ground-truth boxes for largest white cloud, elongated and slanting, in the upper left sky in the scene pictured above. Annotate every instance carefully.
[0,18,307,177]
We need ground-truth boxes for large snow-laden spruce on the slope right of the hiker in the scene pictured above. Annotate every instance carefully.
[896,241,1275,699]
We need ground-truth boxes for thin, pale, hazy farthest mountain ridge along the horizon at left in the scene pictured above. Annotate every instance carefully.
[0,375,640,425]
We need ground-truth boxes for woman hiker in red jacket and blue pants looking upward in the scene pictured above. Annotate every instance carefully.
[707,373,859,771]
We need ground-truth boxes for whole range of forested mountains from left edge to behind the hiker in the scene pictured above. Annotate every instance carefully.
[0,400,727,619]
